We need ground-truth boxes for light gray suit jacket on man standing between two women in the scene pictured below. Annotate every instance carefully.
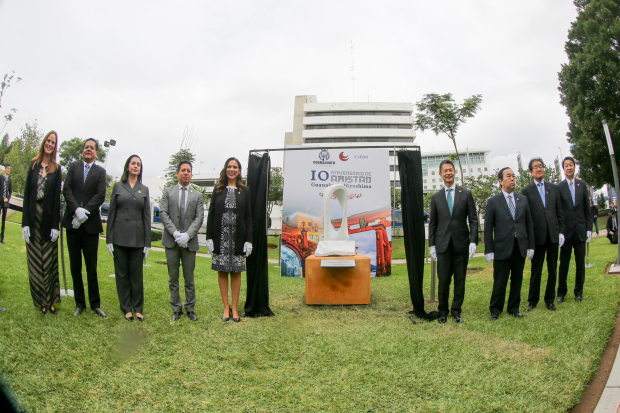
[159,184,205,251]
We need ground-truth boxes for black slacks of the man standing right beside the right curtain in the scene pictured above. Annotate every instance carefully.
[437,240,469,317]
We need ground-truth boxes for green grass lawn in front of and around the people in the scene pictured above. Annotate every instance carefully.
[0,224,620,412]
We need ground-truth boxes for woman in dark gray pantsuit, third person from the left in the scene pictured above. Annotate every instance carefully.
[106,155,151,321]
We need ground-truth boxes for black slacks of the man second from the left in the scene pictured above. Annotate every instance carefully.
[67,227,101,309]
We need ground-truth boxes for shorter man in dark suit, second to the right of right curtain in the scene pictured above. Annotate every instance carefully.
[484,168,534,321]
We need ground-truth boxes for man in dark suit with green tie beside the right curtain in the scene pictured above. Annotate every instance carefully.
[428,159,478,324]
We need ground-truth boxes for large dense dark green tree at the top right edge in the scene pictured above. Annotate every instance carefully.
[558,0,620,187]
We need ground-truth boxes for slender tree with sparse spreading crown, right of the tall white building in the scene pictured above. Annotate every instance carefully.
[415,93,482,182]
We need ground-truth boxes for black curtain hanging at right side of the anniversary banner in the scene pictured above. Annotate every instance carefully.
[398,150,438,320]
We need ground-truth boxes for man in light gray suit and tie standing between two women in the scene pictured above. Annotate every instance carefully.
[159,161,205,321]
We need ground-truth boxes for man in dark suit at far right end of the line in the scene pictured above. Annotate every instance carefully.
[558,156,592,303]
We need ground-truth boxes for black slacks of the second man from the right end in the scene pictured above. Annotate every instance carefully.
[527,234,559,307]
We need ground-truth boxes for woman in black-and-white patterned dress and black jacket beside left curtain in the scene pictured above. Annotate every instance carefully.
[207,157,252,323]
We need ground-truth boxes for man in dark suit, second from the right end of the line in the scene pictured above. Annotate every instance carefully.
[521,158,564,312]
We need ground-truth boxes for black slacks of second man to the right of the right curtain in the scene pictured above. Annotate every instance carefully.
[489,238,525,315]
